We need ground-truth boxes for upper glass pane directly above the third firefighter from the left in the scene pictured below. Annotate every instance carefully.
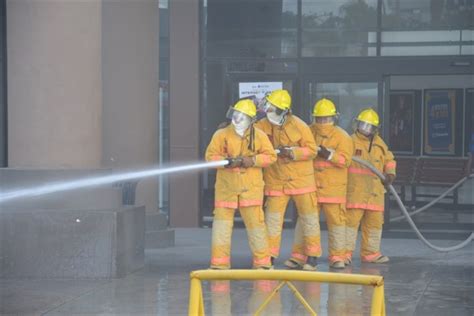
[302,0,377,57]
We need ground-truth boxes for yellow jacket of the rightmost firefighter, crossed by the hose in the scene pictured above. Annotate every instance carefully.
[346,132,396,212]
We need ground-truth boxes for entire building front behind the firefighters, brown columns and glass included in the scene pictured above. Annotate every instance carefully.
[0,0,474,227]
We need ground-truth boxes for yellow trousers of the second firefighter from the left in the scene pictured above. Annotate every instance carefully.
[265,192,321,260]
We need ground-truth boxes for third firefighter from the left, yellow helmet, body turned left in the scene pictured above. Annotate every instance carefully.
[285,98,353,269]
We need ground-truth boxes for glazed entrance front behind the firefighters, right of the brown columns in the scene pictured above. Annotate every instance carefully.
[200,0,474,227]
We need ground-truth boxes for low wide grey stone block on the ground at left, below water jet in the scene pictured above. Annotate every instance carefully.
[0,206,145,279]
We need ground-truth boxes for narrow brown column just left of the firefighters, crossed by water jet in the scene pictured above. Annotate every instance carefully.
[170,0,201,227]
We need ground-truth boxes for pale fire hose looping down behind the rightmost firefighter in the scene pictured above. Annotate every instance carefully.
[352,157,474,252]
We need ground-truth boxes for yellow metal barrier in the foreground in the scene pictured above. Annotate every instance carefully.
[189,270,385,316]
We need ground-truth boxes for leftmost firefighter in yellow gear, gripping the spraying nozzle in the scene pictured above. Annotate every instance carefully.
[206,99,277,269]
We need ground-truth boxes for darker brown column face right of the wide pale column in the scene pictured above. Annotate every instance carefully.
[102,0,159,211]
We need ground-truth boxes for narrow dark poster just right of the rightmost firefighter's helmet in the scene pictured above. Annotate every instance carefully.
[390,91,415,154]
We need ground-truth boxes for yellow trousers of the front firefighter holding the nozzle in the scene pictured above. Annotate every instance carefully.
[211,206,271,269]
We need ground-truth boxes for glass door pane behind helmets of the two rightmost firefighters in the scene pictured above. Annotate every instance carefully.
[309,82,380,134]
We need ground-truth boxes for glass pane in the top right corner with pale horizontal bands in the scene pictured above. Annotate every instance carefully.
[381,0,474,56]
